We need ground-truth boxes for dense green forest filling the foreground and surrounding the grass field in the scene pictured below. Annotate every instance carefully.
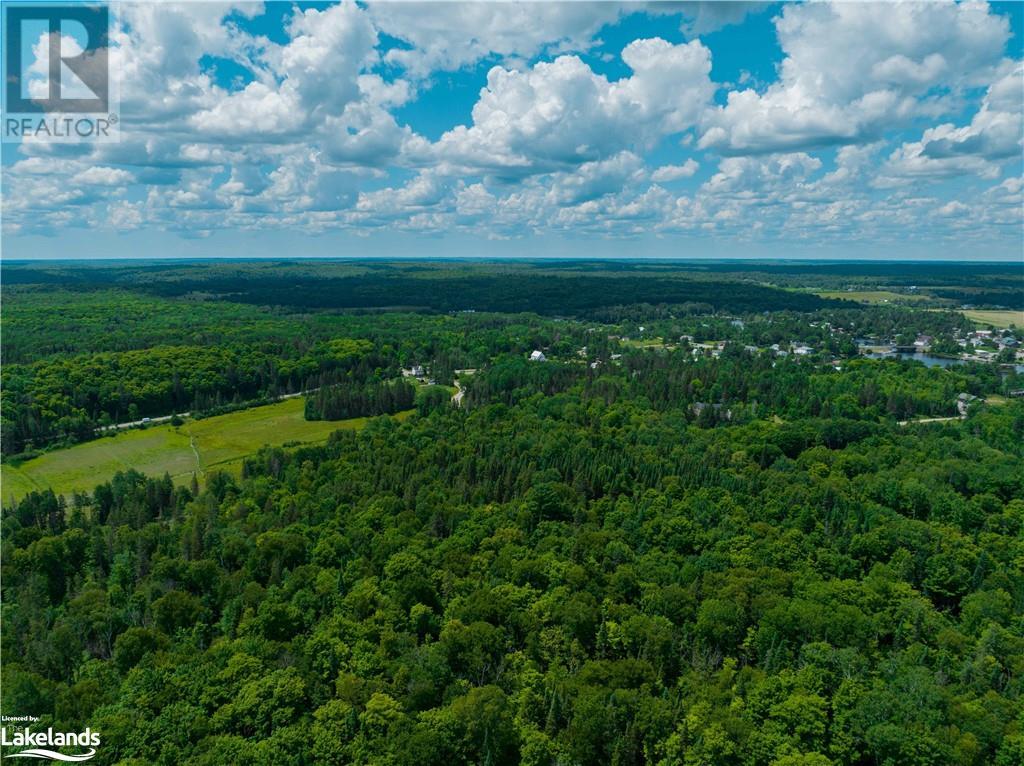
[0,263,1024,766]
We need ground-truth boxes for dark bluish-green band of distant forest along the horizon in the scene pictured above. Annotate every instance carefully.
[4,258,1024,315]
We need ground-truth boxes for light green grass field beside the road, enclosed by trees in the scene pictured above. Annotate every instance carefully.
[0,397,412,501]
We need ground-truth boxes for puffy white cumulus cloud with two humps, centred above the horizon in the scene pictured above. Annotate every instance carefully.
[436,38,714,177]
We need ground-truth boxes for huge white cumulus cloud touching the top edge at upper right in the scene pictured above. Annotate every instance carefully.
[700,2,1010,154]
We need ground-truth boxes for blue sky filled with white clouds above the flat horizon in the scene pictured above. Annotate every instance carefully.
[0,1,1024,261]
